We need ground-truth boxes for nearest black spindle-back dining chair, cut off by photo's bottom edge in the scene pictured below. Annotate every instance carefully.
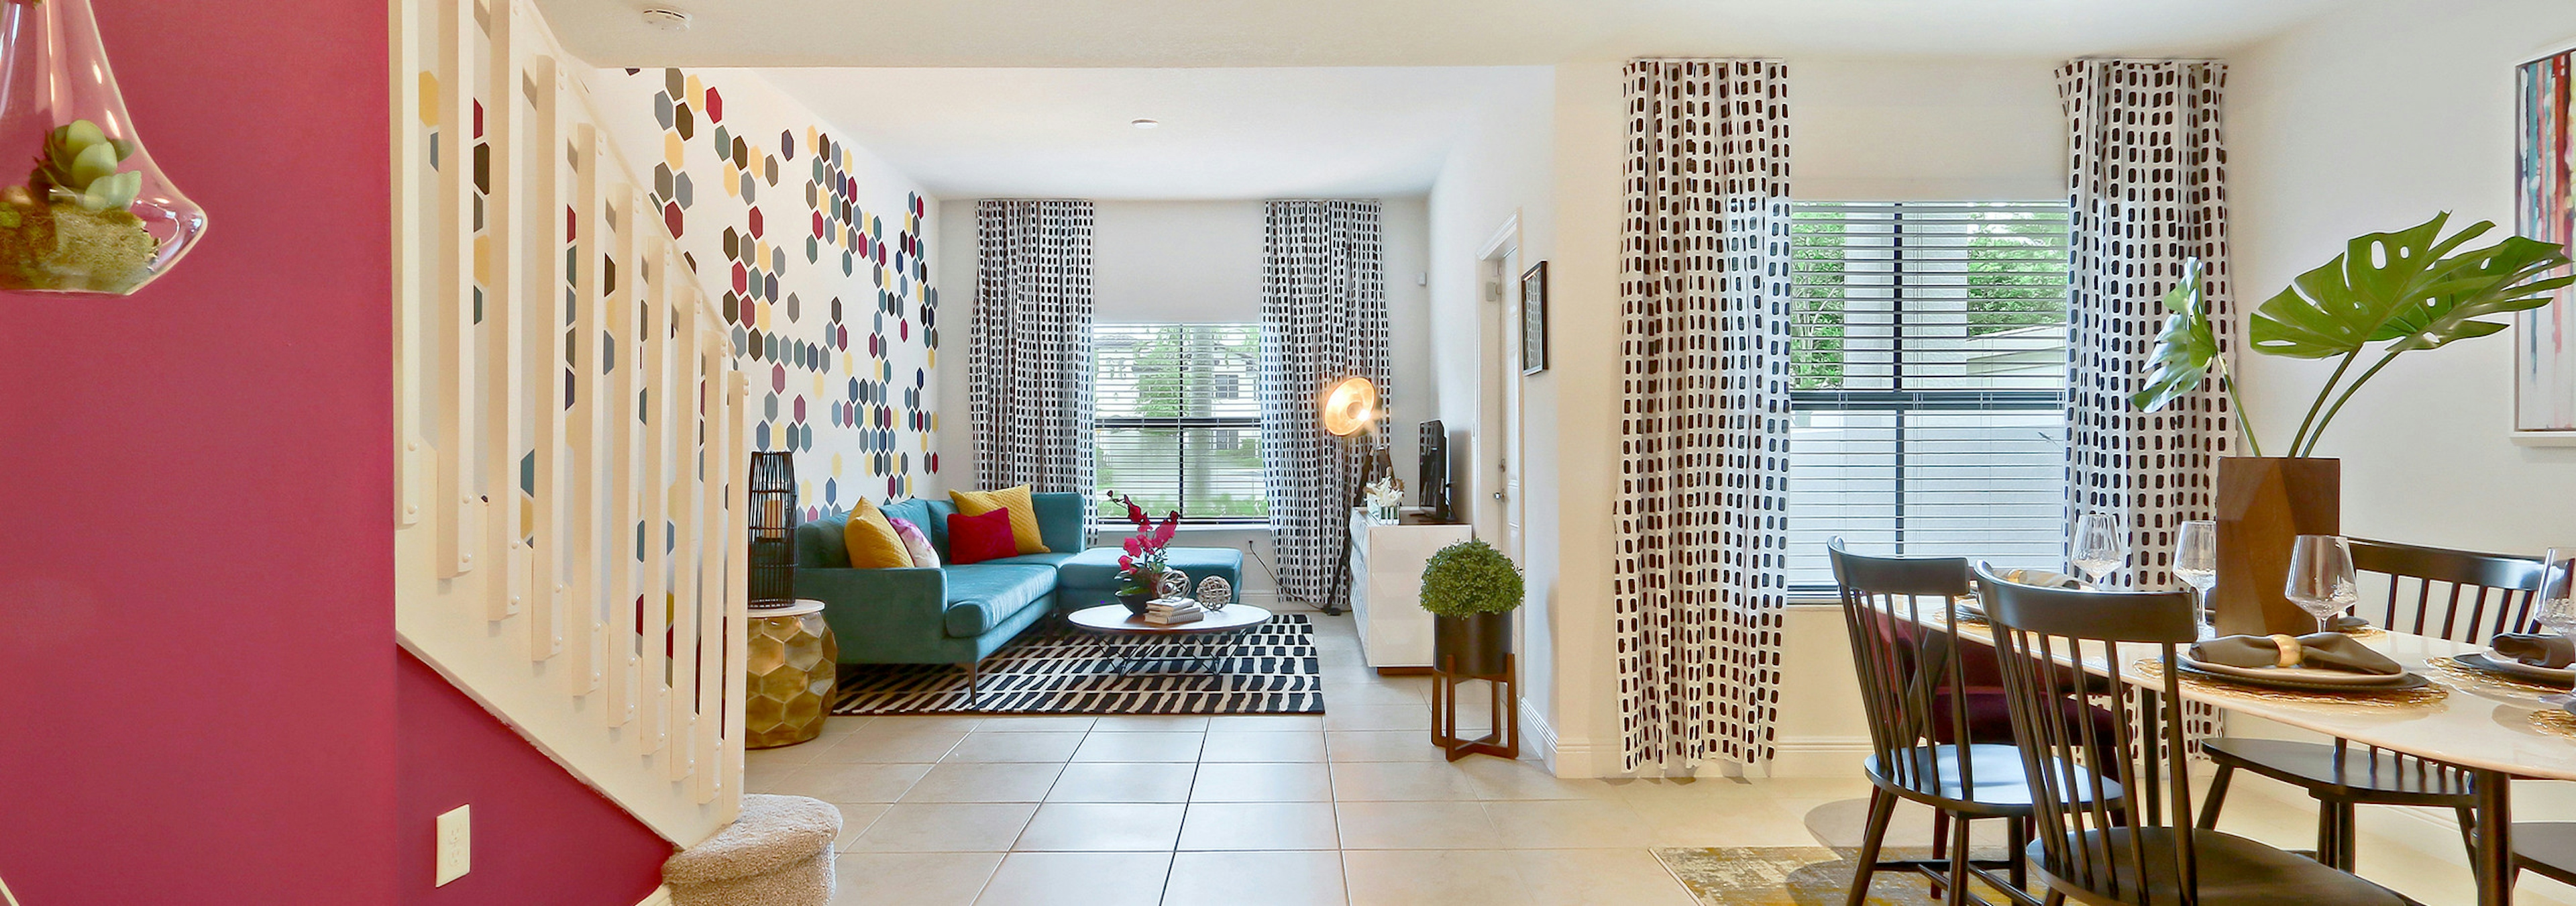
[1976,566,2414,906]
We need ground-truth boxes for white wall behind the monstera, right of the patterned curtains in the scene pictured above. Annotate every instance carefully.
[2229,0,2576,554]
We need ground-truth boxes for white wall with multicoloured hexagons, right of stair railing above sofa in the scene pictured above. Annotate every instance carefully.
[590,70,943,517]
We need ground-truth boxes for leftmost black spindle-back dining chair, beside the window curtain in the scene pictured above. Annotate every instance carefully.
[1827,538,2110,906]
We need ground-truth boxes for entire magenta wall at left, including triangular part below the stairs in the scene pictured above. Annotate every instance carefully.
[0,0,669,906]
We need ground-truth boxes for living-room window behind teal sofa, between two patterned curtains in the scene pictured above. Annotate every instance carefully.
[1092,324,1270,523]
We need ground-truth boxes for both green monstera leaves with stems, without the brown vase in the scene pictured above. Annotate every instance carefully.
[2131,211,2576,456]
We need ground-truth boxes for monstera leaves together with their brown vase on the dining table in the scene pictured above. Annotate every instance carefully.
[2131,211,2576,633]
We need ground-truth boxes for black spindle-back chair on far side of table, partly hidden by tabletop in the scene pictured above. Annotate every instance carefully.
[2200,538,2540,870]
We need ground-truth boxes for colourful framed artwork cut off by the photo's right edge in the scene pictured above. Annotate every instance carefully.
[2514,49,2576,432]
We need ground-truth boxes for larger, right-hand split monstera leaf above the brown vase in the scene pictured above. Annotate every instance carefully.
[2249,213,2576,358]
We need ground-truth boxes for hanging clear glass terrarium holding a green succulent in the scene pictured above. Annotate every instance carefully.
[0,0,206,296]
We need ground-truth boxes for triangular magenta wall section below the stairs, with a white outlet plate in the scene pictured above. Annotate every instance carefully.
[394,654,672,906]
